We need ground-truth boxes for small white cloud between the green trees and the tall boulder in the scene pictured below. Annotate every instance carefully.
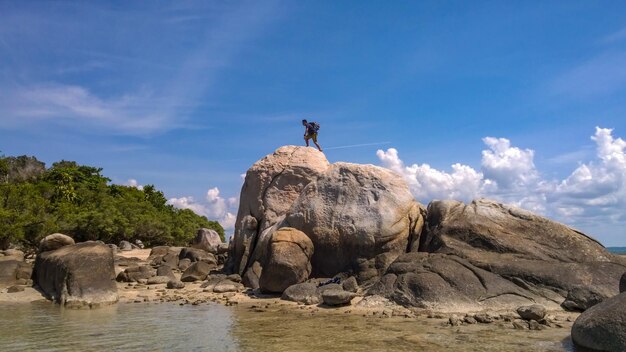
[168,187,239,233]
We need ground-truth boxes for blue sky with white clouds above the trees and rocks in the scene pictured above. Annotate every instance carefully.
[0,0,626,246]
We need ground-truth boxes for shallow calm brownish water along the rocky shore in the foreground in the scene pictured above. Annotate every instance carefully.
[0,302,573,352]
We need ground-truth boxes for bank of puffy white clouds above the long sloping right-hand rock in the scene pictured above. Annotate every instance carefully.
[376,127,626,239]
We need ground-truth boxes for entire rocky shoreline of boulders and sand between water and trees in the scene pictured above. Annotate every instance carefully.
[0,146,626,351]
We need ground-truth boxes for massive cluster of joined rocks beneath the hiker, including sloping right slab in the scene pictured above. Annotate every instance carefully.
[227,146,626,311]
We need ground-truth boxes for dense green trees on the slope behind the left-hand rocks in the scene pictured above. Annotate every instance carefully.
[0,156,224,248]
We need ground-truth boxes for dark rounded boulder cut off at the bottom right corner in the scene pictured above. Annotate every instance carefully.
[572,293,626,352]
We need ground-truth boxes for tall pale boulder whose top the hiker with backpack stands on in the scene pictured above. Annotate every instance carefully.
[226,146,329,275]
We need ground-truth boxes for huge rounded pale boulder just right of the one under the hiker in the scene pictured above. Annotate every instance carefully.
[280,163,423,281]
